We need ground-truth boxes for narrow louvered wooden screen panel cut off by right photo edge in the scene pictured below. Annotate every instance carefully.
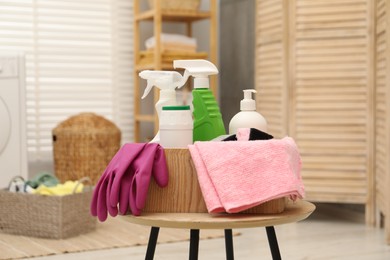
[375,0,390,243]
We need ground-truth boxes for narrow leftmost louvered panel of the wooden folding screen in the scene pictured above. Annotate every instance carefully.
[255,0,288,137]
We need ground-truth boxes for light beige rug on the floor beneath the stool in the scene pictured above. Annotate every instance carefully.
[0,218,233,259]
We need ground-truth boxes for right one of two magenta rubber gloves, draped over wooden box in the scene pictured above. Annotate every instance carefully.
[129,144,168,216]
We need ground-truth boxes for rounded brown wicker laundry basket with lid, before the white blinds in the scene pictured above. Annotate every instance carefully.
[52,113,121,185]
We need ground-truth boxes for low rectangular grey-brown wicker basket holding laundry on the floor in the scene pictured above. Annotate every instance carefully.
[0,190,96,239]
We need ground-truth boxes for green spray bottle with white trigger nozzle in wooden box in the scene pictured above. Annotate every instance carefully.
[173,60,226,142]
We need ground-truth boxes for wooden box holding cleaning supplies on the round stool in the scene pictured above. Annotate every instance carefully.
[143,149,285,213]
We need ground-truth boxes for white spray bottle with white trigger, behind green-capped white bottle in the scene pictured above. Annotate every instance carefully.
[139,70,183,143]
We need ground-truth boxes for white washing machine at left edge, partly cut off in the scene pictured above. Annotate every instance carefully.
[0,51,28,188]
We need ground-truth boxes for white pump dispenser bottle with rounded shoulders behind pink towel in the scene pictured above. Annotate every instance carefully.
[229,89,267,134]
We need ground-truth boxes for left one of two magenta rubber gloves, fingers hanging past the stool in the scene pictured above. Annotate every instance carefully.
[91,144,146,221]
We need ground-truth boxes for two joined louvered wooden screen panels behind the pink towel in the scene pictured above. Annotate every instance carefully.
[255,0,375,223]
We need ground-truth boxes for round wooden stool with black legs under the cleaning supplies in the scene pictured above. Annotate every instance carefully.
[125,201,315,260]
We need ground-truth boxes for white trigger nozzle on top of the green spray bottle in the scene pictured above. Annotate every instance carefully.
[173,60,218,88]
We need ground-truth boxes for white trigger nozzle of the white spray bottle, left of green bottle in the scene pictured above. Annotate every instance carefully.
[139,70,183,99]
